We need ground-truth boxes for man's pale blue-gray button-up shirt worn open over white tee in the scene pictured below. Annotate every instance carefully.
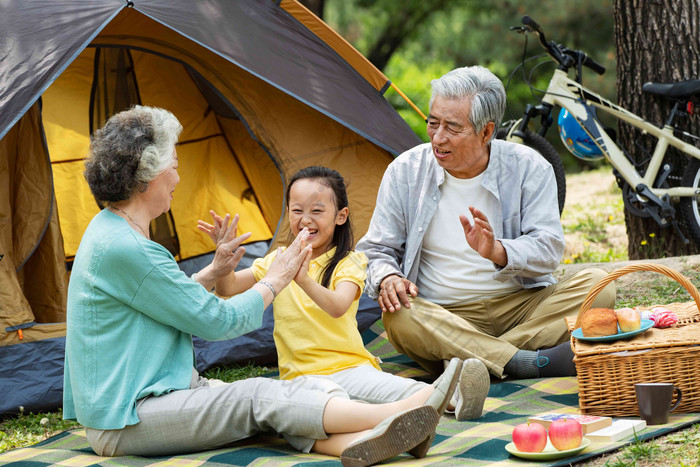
[355,140,564,299]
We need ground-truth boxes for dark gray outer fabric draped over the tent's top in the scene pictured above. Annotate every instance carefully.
[0,0,420,154]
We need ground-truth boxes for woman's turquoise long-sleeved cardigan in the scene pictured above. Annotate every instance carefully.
[63,210,264,430]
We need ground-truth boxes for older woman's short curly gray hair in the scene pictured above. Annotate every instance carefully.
[84,105,182,203]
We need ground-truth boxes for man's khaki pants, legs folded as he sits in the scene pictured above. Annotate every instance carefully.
[382,269,616,378]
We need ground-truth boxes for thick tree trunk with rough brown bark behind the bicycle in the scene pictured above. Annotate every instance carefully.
[613,0,700,259]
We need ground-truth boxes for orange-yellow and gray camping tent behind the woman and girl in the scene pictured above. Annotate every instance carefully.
[0,0,420,414]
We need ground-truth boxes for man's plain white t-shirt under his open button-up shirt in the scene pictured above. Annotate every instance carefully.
[416,171,520,305]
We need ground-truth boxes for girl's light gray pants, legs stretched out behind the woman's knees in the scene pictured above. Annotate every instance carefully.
[304,365,429,404]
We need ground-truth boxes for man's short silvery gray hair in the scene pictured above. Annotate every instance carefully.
[430,65,506,139]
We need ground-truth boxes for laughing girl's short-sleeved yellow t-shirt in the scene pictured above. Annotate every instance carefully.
[252,248,380,379]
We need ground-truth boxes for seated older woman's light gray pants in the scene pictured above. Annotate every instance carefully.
[85,372,349,456]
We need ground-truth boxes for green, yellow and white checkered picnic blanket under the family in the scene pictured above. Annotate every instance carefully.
[0,322,700,467]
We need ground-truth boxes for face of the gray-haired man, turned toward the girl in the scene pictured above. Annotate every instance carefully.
[428,96,494,178]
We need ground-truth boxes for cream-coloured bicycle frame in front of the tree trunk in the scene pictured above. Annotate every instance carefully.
[507,69,700,201]
